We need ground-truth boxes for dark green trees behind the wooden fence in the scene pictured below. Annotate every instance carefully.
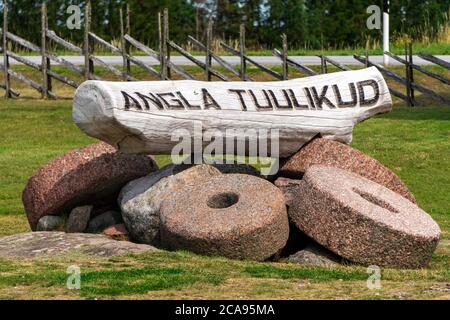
[0,0,450,49]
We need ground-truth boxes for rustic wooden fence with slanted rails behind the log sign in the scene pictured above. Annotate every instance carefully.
[0,1,450,106]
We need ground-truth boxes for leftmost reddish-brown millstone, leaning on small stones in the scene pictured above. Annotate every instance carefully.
[22,143,157,230]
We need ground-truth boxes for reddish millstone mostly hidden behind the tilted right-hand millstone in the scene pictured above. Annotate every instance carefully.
[278,138,416,203]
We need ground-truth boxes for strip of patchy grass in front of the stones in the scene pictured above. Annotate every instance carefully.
[0,244,450,299]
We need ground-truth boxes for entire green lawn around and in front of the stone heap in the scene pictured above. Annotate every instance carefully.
[0,65,450,299]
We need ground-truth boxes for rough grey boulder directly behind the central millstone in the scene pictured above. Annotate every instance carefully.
[118,165,221,246]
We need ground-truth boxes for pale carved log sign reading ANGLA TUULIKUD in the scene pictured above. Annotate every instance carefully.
[73,67,392,157]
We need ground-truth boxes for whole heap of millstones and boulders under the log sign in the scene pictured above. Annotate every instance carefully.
[7,138,440,268]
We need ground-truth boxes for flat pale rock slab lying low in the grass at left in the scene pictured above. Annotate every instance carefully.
[0,232,158,258]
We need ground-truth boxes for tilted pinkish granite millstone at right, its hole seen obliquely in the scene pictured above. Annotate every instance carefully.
[289,166,440,268]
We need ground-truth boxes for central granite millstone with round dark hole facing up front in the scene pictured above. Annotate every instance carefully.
[160,174,289,261]
